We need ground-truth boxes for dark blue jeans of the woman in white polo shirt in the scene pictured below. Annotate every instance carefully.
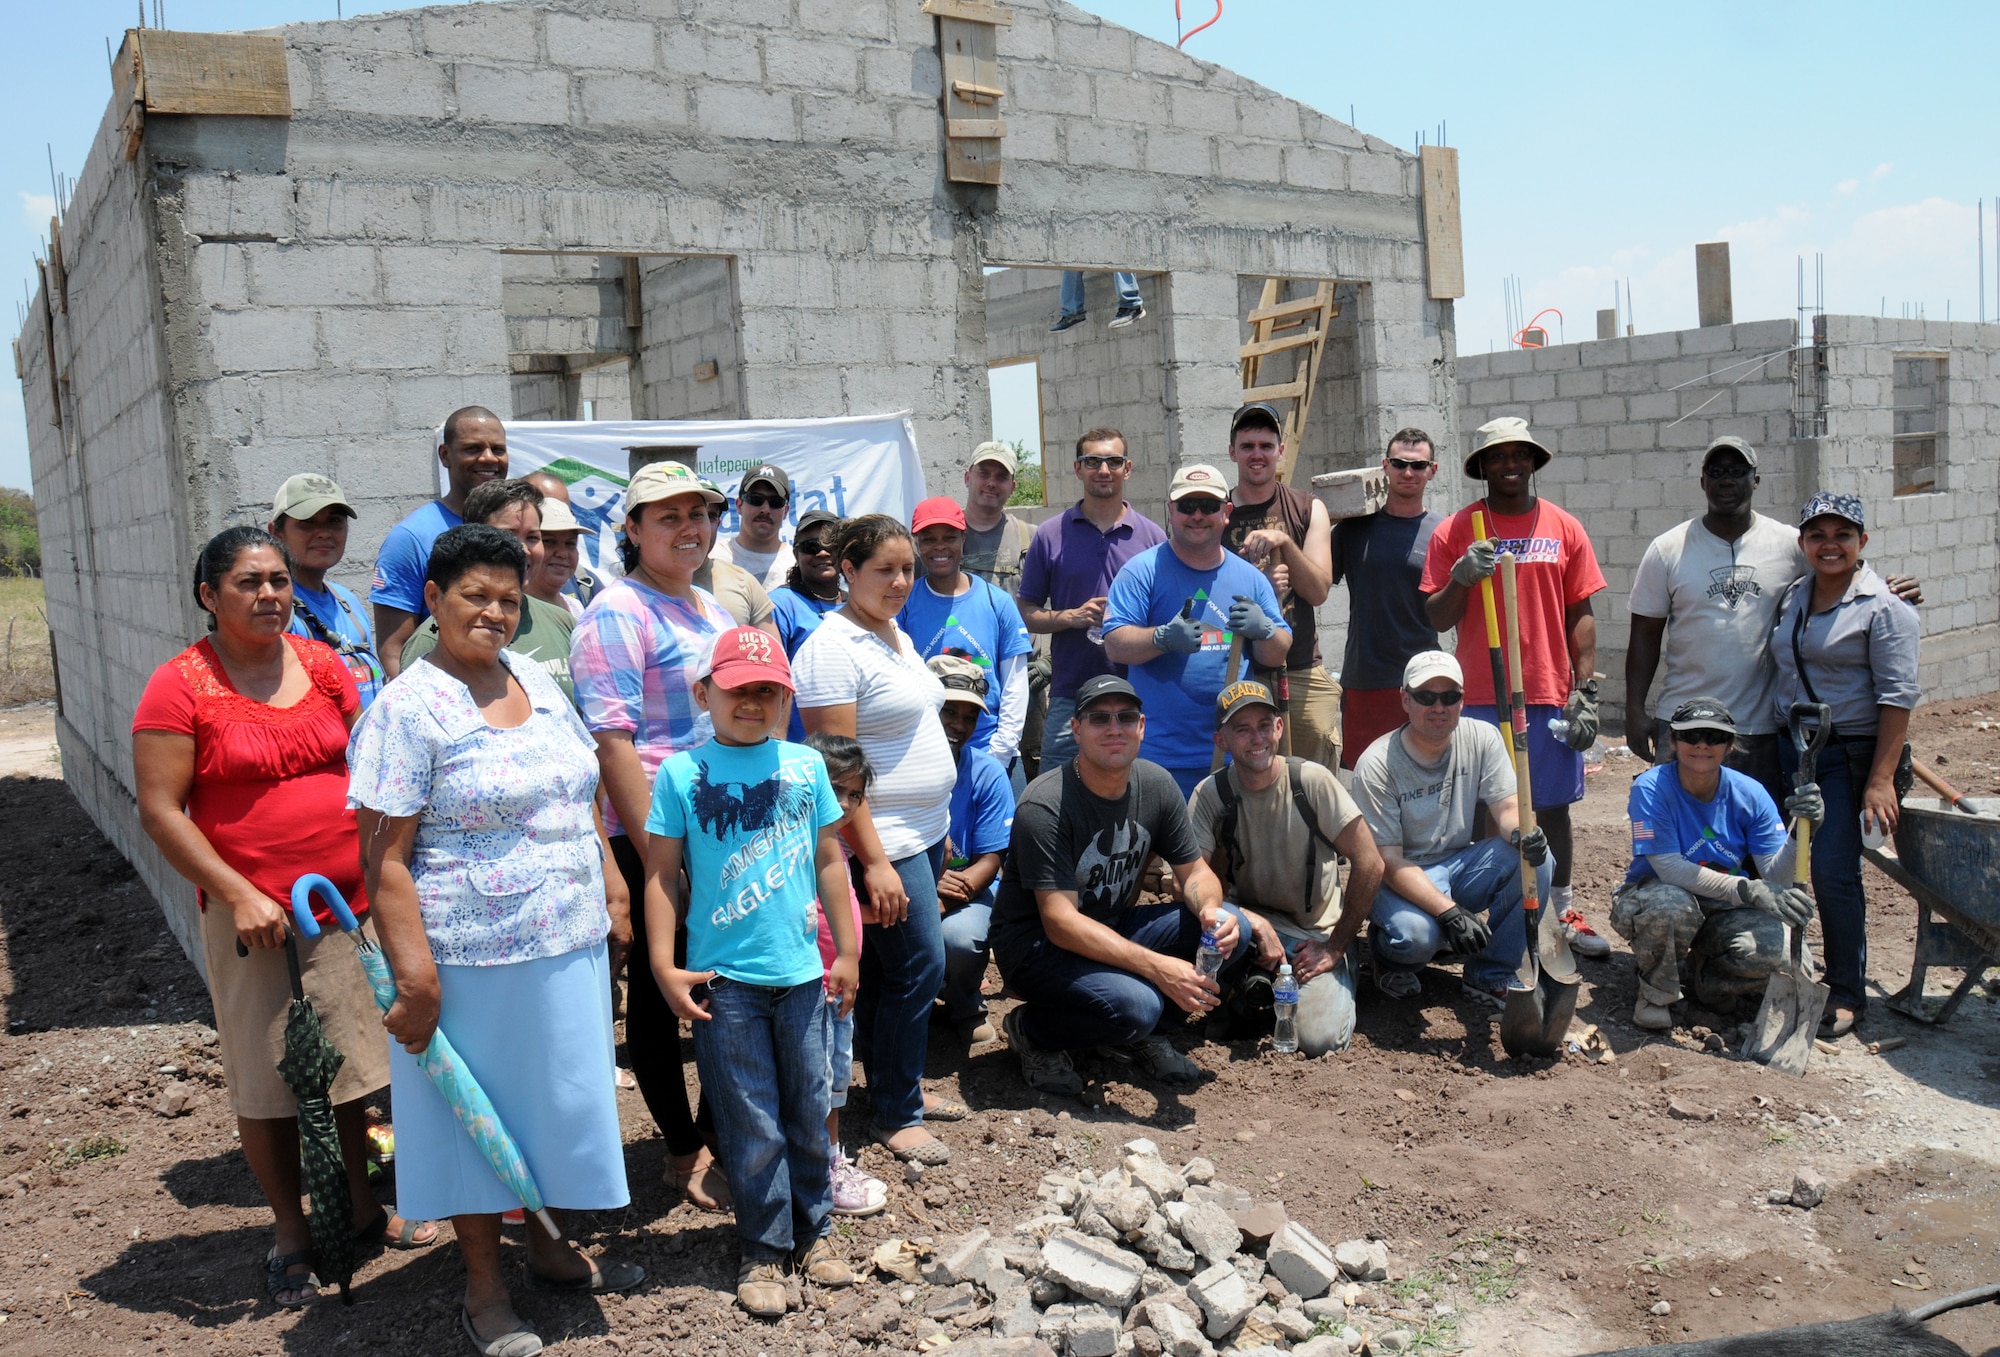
[856,839,944,1141]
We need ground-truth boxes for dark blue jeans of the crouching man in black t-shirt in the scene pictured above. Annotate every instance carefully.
[1006,905,1252,1051]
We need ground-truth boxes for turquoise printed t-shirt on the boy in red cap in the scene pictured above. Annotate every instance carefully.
[646,741,840,989]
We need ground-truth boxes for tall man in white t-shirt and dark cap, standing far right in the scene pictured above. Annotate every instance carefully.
[1626,434,1924,801]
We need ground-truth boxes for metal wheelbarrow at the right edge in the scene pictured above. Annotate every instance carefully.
[1862,797,2000,1025]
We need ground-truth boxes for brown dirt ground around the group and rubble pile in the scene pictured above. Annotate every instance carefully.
[0,695,2000,1355]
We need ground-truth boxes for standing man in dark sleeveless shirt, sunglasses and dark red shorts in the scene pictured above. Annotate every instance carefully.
[1332,428,1444,769]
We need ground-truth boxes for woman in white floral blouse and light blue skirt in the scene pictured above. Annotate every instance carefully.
[348,524,646,1357]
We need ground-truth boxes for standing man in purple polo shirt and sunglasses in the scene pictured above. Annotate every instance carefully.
[1020,428,1166,773]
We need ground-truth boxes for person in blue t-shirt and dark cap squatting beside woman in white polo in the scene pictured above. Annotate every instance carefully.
[930,654,1014,1047]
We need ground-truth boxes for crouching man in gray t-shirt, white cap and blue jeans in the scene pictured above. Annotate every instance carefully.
[1354,650,1550,1009]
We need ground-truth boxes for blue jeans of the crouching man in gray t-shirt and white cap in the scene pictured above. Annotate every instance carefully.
[1368,839,1554,993]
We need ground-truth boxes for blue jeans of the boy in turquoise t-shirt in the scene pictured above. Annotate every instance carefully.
[694,975,834,1263]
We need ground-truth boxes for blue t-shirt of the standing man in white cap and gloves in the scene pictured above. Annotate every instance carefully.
[1104,542,1284,769]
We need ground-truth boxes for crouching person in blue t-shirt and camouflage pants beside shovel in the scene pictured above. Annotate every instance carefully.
[1612,697,1826,1031]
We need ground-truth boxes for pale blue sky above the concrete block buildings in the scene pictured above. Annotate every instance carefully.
[0,0,2000,486]
